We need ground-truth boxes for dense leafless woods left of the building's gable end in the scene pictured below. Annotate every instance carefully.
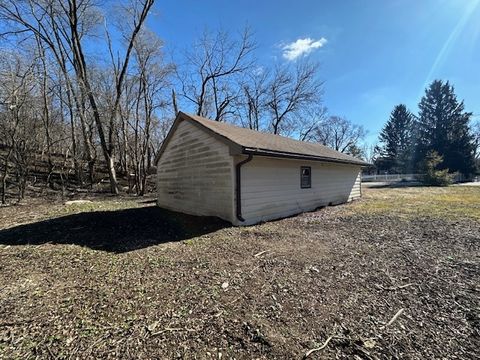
[0,0,173,202]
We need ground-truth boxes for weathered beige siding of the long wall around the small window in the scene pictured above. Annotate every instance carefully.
[236,157,361,225]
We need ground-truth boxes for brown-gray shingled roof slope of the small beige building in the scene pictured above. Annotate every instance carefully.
[179,112,369,166]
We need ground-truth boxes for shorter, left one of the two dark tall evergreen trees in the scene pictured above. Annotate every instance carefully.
[379,104,415,173]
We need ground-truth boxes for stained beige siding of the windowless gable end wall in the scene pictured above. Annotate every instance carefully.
[157,121,233,221]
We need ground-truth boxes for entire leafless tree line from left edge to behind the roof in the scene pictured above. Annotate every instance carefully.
[0,0,364,202]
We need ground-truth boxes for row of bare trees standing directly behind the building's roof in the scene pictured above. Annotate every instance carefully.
[176,28,366,150]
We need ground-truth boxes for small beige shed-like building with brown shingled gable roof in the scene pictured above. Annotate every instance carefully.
[156,112,369,225]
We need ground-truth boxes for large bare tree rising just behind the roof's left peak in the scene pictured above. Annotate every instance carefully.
[177,28,255,121]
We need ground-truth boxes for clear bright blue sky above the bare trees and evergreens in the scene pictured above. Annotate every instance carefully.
[148,0,480,143]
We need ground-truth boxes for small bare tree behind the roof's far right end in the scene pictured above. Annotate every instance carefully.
[314,116,366,153]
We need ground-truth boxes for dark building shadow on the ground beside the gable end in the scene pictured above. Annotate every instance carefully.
[0,206,231,253]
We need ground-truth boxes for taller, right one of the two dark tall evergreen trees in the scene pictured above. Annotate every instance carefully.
[417,80,475,174]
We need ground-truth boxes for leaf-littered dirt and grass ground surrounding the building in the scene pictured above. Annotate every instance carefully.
[0,187,480,359]
